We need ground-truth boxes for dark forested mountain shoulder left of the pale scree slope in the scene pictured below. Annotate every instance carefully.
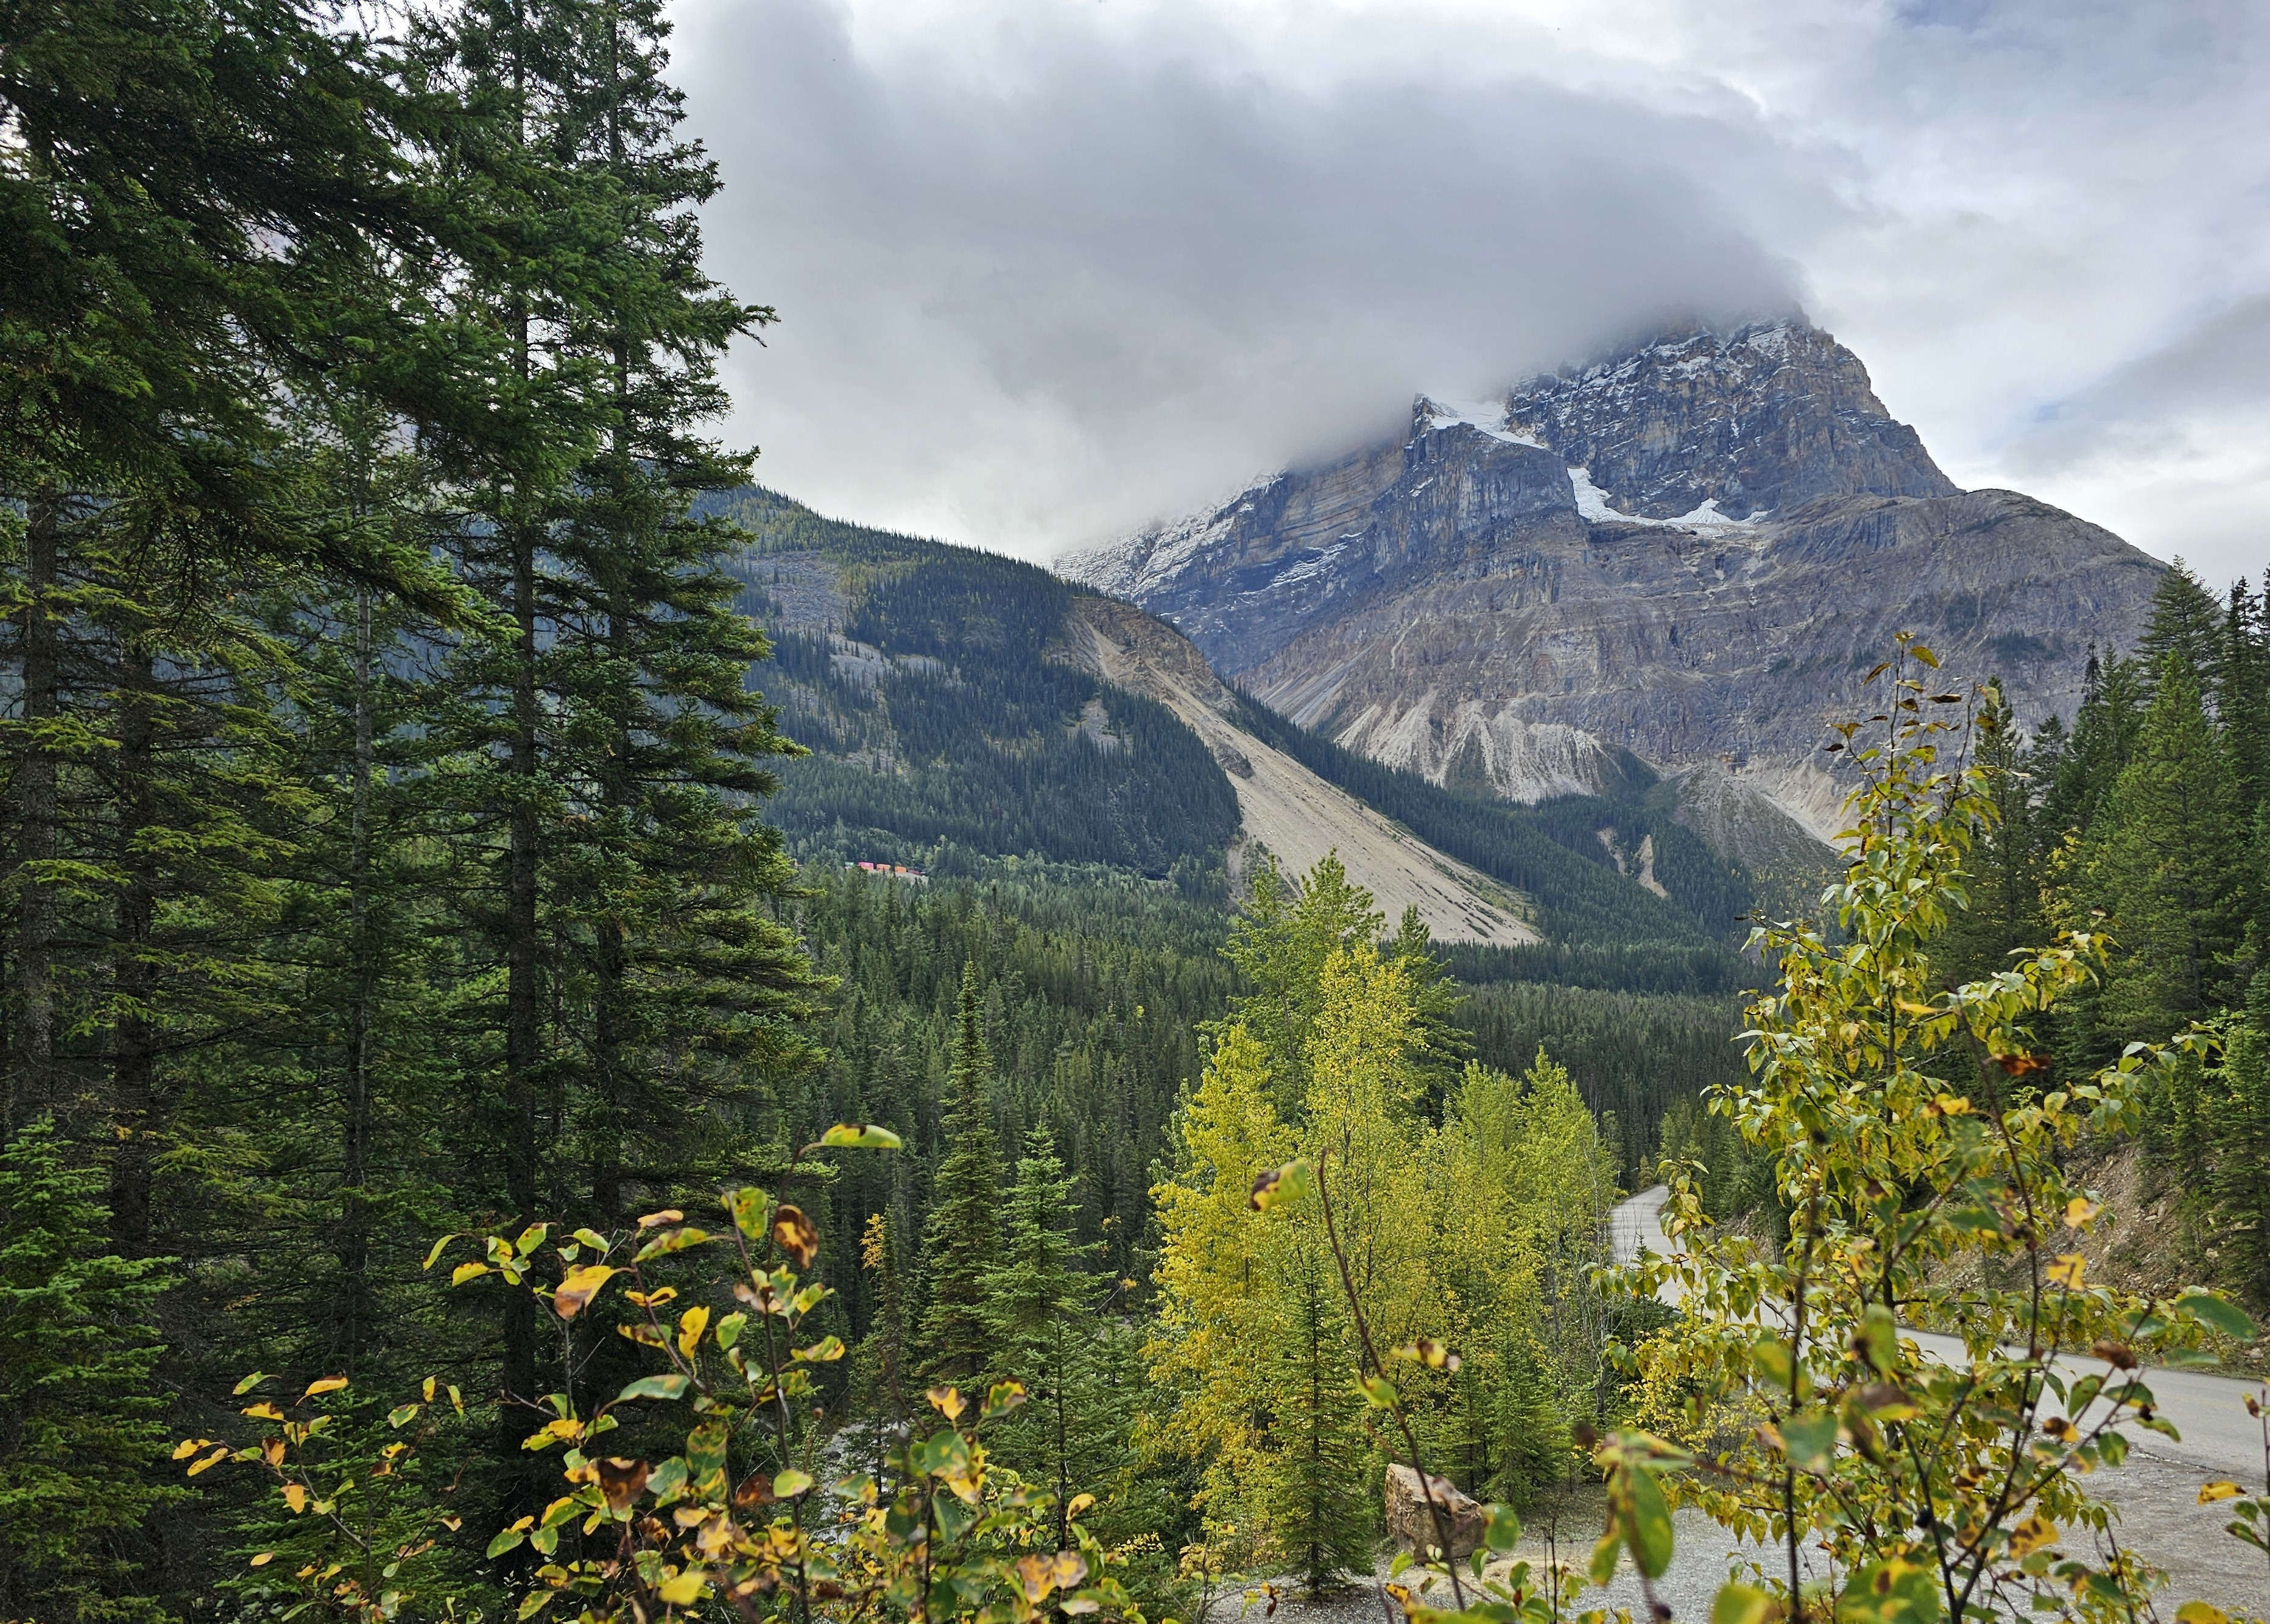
[715,488,1237,878]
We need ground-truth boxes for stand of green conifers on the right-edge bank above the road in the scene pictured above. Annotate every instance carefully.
[1945,564,2270,1307]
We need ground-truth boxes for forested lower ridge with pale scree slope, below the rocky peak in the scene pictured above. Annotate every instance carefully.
[706,488,1748,952]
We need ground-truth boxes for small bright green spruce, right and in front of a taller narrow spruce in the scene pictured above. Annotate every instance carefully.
[983,1125,1103,1549]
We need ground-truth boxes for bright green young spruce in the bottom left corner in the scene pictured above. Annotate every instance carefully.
[0,1120,182,1624]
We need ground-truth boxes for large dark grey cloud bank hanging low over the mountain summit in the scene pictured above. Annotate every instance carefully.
[679,0,1839,556]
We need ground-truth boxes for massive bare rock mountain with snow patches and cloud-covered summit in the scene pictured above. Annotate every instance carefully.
[1060,317,2161,871]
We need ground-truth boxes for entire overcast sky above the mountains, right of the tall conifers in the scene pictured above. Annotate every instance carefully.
[677,0,2270,583]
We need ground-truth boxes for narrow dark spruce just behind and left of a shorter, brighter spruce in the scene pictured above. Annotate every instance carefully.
[922,964,1001,1381]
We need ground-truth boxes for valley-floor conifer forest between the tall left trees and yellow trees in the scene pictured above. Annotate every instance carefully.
[799,864,1235,1306]
